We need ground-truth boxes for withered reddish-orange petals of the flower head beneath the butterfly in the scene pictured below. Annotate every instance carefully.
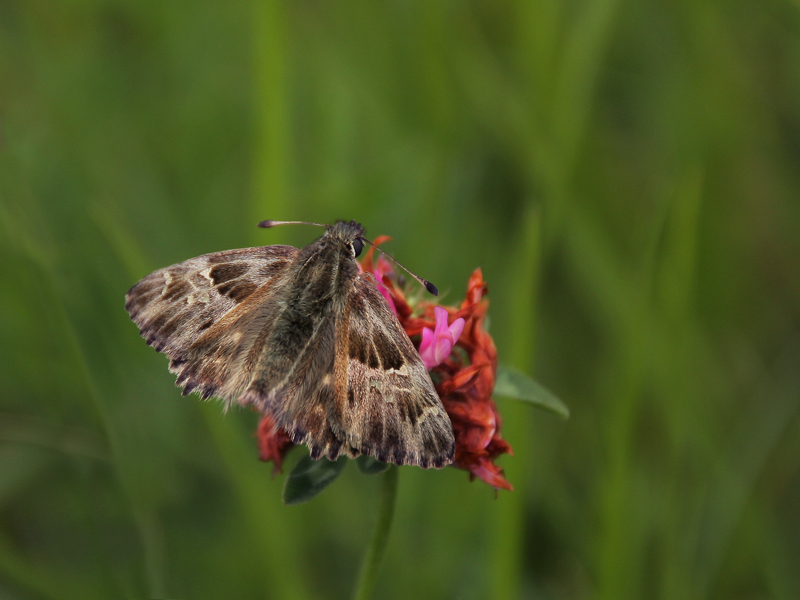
[258,236,513,490]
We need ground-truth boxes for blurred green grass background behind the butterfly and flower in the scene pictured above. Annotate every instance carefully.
[0,0,800,600]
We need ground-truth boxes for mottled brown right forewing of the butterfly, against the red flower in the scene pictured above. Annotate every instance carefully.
[331,275,455,468]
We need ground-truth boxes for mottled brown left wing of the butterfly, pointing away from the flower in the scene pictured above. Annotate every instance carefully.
[125,245,297,400]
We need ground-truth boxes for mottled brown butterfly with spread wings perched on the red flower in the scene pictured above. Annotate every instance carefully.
[125,221,454,468]
